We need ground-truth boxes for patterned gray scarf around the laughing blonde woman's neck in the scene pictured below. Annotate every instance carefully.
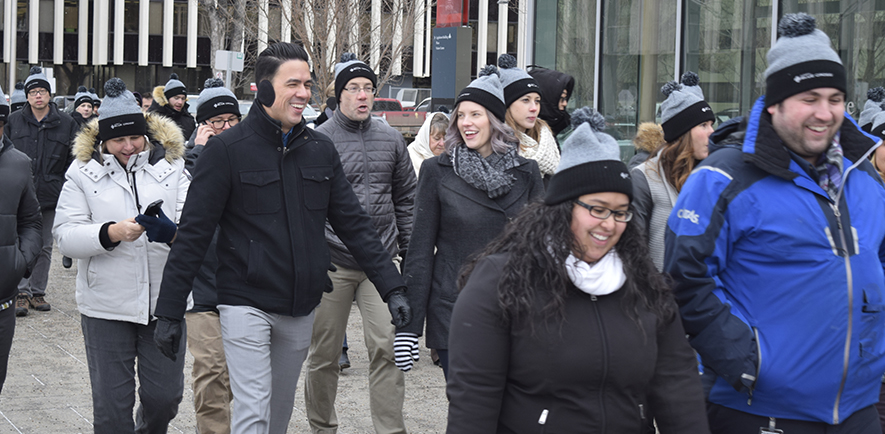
[452,143,518,199]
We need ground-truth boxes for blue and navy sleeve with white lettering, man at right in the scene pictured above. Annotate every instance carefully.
[664,167,756,391]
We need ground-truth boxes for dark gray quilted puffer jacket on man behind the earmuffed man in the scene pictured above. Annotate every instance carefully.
[316,110,418,270]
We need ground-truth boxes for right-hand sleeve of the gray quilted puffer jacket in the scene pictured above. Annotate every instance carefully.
[391,134,418,252]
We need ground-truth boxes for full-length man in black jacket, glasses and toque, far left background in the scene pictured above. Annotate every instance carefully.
[6,66,79,316]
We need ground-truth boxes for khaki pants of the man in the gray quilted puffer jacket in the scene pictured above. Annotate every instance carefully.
[304,265,406,434]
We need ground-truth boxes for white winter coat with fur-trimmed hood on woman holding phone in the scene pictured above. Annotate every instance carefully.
[52,113,190,324]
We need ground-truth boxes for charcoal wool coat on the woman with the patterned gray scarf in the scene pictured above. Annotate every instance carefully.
[397,153,544,350]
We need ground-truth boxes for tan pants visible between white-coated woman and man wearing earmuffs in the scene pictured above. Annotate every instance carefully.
[185,312,233,434]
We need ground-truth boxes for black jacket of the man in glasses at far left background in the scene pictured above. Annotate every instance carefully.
[4,102,80,209]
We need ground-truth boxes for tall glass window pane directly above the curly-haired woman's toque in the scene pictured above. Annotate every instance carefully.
[596,0,676,139]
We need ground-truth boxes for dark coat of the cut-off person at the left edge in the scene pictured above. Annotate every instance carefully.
[0,136,43,304]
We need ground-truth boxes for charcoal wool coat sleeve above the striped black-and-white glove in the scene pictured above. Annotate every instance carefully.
[397,162,441,336]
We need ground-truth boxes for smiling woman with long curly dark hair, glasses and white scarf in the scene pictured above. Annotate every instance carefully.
[446,108,710,434]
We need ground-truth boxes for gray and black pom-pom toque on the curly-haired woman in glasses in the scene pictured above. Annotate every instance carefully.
[544,107,633,205]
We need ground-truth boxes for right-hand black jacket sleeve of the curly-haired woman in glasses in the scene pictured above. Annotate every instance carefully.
[648,300,710,434]
